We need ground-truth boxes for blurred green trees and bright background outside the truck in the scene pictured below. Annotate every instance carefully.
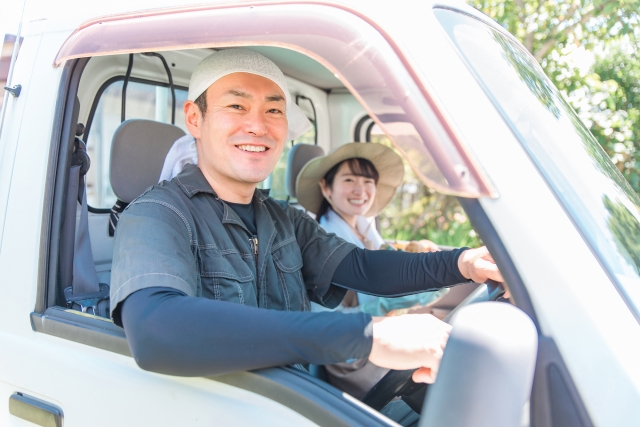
[0,0,640,246]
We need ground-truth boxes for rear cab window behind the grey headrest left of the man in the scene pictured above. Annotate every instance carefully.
[86,79,187,208]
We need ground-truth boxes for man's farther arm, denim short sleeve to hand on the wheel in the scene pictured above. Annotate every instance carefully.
[281,202,502,307]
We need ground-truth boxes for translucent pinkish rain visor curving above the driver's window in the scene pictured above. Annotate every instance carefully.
[54,5,497,197]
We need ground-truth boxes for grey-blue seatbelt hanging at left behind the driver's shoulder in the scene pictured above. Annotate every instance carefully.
[61,138,109,317]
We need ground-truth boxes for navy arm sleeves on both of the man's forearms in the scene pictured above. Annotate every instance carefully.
[120,248,466,376]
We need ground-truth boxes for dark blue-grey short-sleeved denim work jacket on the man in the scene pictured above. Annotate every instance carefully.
[111,165,355,313]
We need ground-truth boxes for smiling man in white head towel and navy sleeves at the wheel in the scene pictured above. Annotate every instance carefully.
[111,49,502,388]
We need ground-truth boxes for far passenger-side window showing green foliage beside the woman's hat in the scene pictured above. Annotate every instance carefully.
[369,125,482,247]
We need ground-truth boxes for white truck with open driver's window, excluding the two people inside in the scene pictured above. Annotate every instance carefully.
[0,0,640,427]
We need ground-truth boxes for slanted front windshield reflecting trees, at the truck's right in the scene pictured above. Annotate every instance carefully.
[435,9,640,318]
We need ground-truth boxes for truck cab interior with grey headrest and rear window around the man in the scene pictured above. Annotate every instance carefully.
[41,46,498,424]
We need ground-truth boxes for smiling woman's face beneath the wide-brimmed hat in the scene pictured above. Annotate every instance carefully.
[321,162,376,219]
